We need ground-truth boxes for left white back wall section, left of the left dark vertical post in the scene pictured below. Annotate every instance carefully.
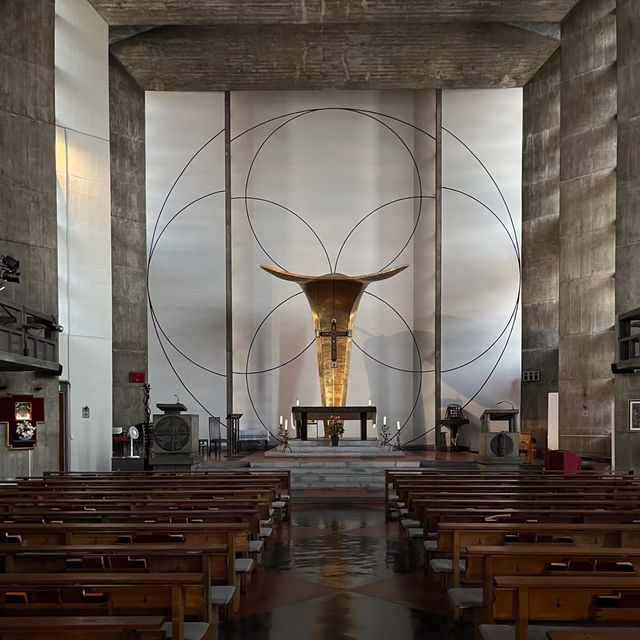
[146,91,226,438]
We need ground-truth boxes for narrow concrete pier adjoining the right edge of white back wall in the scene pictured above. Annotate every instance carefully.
[520,52,560,453]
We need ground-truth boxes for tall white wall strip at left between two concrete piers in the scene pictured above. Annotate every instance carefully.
[55,0,112,471]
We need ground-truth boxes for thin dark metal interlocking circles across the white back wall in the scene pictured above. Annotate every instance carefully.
[147,107,522,450]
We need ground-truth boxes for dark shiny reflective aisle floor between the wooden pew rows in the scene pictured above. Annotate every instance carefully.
[220,505,473,640]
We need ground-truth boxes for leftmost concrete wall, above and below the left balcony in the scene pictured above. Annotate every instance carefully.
[0,0,59,479]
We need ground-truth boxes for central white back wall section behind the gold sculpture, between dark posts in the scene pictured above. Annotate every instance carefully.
[232,91,434,437]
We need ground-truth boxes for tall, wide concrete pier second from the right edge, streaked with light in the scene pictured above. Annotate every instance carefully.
[558,0,617,456]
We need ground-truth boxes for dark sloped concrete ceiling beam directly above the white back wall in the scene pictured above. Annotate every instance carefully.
[111,23,559,91]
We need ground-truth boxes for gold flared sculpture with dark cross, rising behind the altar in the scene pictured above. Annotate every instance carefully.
[260,264,409,407]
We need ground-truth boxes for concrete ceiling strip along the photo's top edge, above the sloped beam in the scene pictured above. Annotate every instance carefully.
[85,0,576,25]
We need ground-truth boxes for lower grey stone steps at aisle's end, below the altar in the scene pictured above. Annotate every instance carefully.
[251,459,420,495]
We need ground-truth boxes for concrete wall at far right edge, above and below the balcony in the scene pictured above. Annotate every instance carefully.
[615,0,640,471]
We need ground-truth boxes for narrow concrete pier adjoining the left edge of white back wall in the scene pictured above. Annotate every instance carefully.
[109,58,147,426]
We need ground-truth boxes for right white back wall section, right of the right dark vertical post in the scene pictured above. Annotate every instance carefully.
[442,89,522,450]
